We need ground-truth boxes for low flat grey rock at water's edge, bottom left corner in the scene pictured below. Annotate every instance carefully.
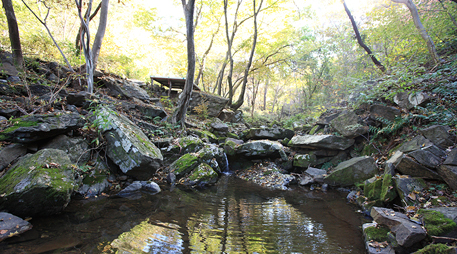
[0,212,32,242]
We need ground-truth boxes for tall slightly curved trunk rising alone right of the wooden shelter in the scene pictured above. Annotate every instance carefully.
[171,0,195,128]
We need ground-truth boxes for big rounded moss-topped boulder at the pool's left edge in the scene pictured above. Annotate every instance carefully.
[0,149,77,217]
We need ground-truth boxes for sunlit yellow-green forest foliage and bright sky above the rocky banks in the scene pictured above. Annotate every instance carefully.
[0,0,457,118]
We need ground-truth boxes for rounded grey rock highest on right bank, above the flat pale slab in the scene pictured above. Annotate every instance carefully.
[330,111,368,138]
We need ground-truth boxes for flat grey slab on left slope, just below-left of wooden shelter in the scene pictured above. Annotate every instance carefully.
[102,76,151,102]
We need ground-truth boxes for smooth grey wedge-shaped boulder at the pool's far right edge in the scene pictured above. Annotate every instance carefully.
[324,156,378,187]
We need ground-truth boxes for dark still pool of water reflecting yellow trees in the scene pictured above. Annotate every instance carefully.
[0,176,365,254]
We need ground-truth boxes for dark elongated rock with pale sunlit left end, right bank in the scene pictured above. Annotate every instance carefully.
[387,151,442,180]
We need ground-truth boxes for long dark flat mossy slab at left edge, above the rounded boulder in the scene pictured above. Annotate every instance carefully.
[0,113,85,143]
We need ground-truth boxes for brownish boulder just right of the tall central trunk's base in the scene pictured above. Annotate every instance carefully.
[189,91,228,117]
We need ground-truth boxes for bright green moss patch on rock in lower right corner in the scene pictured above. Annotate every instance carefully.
[417,209,456,236]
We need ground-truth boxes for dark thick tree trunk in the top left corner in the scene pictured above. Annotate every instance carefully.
[2,0,24,69]
